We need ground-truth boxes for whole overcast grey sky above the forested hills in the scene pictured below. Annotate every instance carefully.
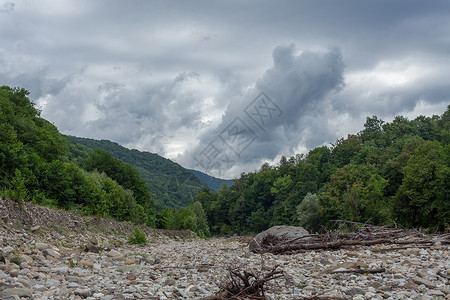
[0,0,450,178]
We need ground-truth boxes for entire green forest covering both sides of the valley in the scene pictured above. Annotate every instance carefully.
[0,86,450,237]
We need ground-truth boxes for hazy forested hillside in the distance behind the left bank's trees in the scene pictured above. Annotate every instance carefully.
[67,136,207,208]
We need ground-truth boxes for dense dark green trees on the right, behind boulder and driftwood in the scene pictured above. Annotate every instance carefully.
[195,106,450,234]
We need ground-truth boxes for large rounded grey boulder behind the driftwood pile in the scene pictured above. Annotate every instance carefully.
[248,225,309,252]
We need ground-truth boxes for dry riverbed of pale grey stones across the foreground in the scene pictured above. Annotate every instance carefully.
[0,200,450,300]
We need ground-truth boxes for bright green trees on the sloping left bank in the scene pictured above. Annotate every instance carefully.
[0,86,209,237]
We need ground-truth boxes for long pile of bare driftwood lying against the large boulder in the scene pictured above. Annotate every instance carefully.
[254,221,450,254]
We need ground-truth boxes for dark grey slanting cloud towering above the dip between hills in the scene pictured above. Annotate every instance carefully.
[183,45,344,176]
